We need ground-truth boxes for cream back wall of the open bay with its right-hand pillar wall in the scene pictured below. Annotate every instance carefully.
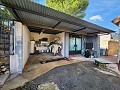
[30,32,69,57]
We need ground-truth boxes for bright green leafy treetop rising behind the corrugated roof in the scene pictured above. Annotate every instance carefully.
[46,0,89,18]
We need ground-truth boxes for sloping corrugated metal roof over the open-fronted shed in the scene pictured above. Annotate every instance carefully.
[1,0,114,35]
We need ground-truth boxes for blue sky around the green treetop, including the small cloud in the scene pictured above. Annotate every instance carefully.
[33,0,120,31]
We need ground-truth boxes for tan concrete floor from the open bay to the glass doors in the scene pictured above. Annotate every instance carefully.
[1,55,120,90]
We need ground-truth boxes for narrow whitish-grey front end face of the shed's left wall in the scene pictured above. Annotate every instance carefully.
[10,22,23,73]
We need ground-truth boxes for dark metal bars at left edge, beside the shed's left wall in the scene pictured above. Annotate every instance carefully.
[0,17,14,57]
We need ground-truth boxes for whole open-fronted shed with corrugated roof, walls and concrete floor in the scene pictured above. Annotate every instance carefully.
[0,0,119,90]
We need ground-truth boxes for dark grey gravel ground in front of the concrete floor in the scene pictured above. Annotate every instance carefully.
[15,62,120,90]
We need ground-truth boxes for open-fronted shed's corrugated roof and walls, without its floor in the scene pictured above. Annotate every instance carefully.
[0,0,114,83]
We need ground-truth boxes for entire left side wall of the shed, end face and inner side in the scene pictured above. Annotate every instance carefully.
[10,22,30,73]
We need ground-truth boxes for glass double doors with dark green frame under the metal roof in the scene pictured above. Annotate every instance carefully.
[69,36,82,54]
